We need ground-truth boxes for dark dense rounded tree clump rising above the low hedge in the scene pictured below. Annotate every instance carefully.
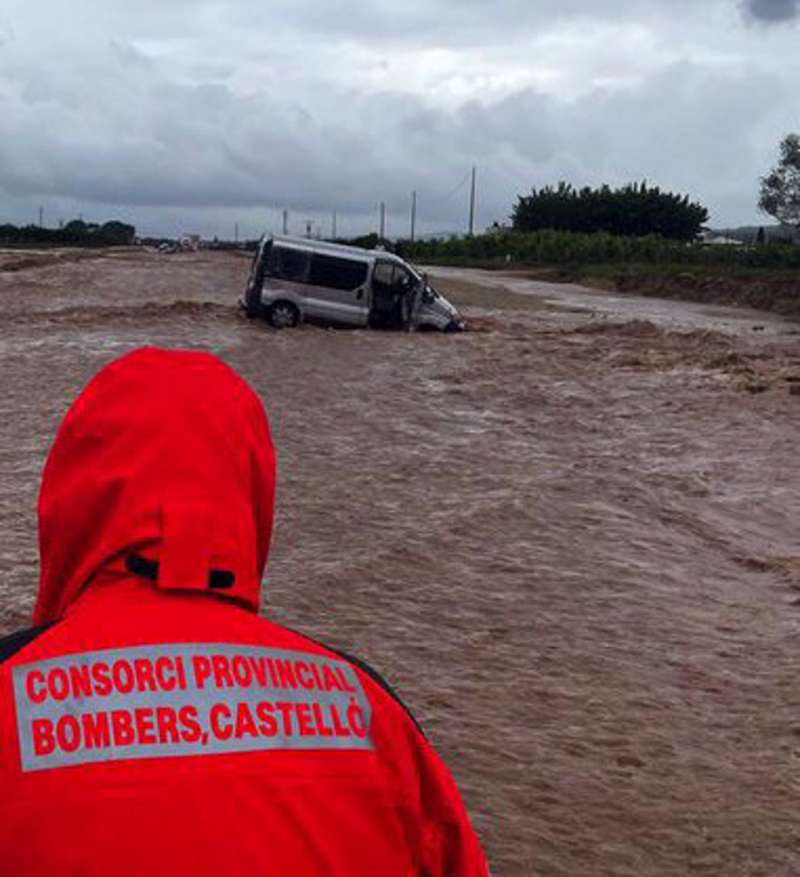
[512,182,708,241]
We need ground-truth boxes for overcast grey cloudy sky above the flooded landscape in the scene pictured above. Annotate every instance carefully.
[0,0,800,237]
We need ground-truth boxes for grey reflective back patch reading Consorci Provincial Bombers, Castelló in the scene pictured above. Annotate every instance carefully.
[14,644,372,771]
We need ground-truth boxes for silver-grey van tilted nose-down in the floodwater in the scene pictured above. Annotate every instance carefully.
[242,235,464,332]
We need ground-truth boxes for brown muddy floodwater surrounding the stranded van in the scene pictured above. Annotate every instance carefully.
[0,250,800,877]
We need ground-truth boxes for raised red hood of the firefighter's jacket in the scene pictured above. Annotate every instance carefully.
[34,348,275,624]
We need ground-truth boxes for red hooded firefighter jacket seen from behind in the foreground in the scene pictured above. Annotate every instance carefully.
[0,349,488,877]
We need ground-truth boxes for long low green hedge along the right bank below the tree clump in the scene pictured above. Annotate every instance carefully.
[395,231,800,269]
